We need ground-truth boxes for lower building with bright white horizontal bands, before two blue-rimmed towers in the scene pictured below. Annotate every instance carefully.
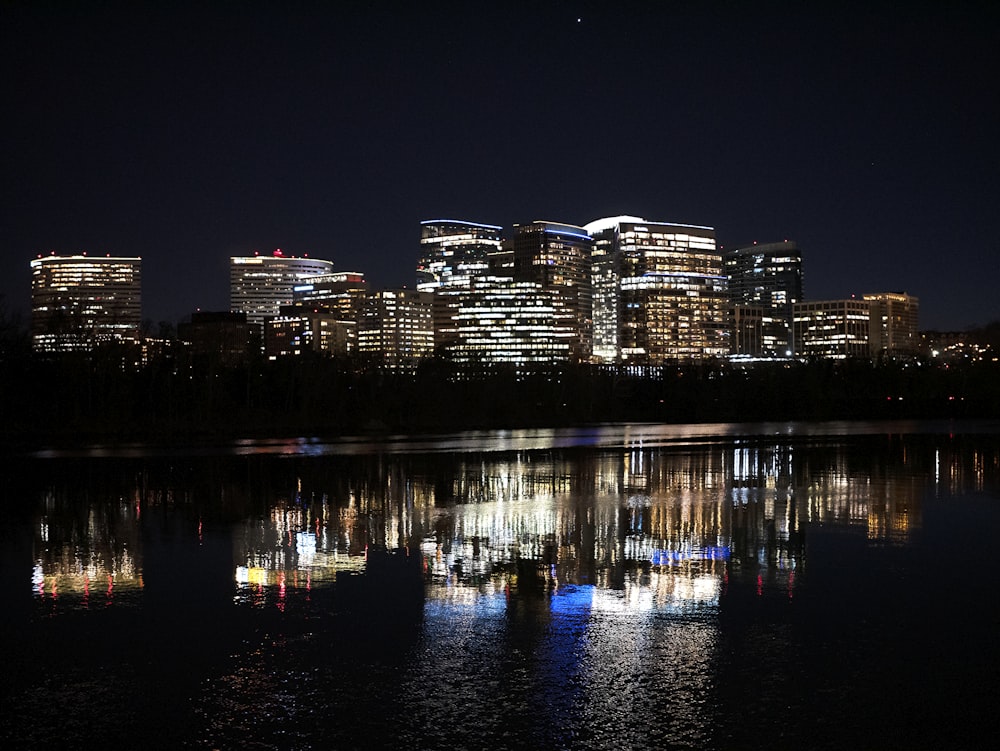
[434,277,575,369]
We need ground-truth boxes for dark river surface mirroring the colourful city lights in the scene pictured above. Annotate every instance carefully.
[0,424,1000,748]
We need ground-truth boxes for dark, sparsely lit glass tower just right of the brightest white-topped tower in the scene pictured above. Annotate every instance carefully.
[722,240,802,357]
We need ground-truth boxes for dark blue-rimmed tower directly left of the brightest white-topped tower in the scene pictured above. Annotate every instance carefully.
[512,221,594,362]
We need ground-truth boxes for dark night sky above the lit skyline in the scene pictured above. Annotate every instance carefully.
[0,0,1000,329]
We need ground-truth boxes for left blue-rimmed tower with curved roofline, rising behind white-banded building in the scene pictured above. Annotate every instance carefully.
[417,219,501,292]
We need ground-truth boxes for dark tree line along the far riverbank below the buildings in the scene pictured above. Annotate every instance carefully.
[0,304,1000,445]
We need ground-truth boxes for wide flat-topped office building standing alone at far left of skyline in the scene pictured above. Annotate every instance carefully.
[31,255,142,352]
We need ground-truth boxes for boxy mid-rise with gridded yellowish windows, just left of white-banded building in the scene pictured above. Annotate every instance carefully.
[357,289,434,369]
